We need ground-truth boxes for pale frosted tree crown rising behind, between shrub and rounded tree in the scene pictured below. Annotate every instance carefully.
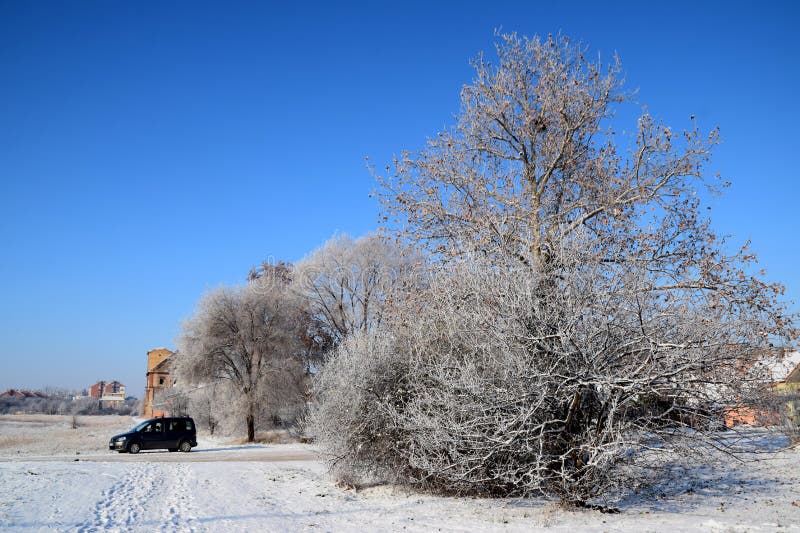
[294,234,423,344]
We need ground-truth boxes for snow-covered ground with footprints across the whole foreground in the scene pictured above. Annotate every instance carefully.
[0,417,800,532]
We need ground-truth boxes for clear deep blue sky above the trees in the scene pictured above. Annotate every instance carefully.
[0,0,800,397]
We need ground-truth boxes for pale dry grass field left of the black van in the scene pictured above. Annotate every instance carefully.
[0,415,135,455]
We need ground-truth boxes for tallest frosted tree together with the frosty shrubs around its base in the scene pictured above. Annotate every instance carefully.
[313,34,796,504]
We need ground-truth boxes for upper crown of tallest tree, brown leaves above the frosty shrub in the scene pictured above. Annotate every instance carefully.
[380,34,797,362]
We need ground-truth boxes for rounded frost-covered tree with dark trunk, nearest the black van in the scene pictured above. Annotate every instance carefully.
[176,265,304,442]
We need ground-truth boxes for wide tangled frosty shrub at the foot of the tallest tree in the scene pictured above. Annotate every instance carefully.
[312,247,788,503]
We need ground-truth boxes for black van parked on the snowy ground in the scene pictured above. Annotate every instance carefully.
[108,416,197,453]
